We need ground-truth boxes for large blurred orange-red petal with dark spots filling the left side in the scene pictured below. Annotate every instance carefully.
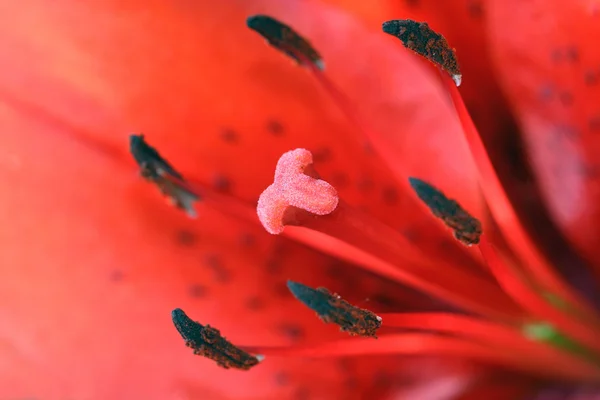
[0,0,482,399]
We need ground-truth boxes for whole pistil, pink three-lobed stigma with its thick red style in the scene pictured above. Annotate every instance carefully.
[257,149,520,320]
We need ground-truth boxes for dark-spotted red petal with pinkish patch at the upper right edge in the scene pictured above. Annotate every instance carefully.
[489,0,600,265]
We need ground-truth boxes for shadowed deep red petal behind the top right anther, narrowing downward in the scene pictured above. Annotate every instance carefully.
[324,0,523,173]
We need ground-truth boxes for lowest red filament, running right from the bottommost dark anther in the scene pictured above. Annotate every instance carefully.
[241,332,600,382]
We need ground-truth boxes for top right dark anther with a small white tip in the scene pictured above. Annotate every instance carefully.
[383,19,462,86]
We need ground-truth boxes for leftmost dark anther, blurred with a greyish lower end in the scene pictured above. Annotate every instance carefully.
[129,135,199,218]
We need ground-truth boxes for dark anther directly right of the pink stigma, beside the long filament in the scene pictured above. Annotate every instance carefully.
[408,178,482,246]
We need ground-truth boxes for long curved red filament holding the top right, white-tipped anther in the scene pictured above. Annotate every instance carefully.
[440,70,600,327]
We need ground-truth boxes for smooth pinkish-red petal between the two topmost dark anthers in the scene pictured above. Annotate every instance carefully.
[302,0,488,212]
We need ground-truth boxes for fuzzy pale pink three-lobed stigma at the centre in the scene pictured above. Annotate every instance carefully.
[256,149,339,234]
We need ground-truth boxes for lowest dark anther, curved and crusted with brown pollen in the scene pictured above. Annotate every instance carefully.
[171,308,264,371]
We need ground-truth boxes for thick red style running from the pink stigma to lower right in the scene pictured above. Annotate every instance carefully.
[284,201,522,321]
